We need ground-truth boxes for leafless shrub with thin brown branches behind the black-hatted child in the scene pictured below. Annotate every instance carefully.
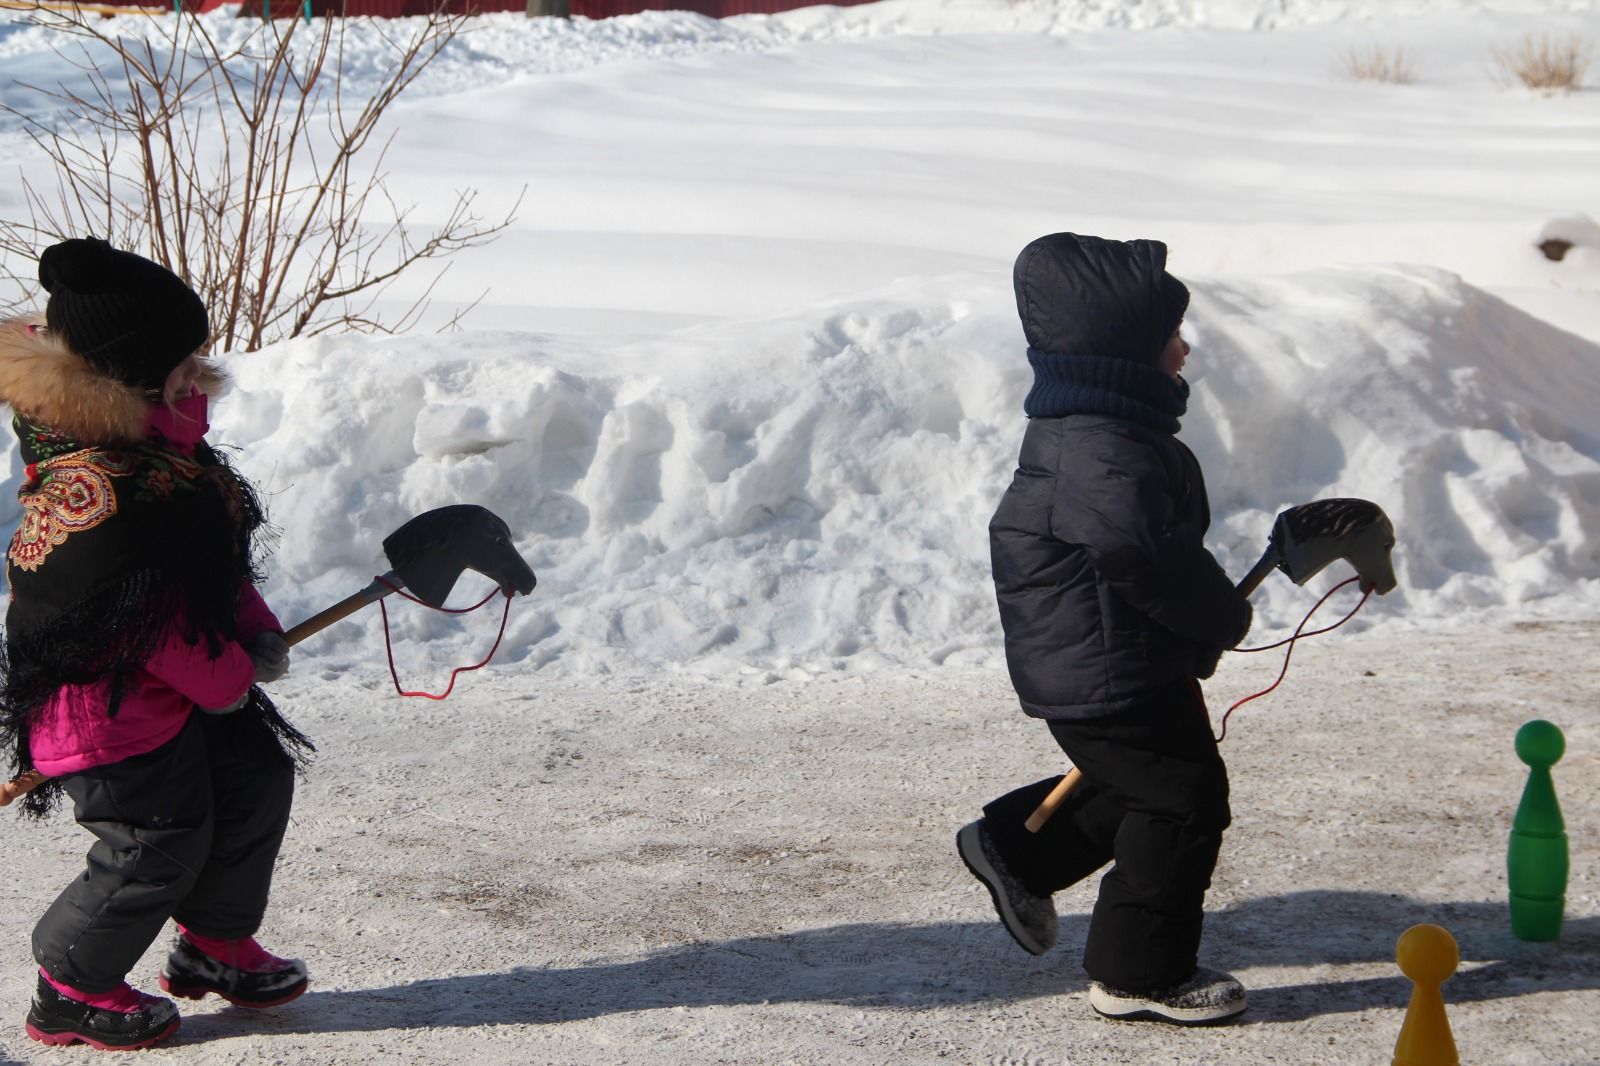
[0,8,522,351]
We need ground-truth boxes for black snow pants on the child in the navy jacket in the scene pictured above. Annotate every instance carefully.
[984,680,1232,991]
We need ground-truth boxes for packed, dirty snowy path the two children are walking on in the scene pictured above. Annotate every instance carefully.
[0,623,1600,1066]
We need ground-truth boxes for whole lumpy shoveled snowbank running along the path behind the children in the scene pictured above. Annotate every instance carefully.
[131,266,1600,679]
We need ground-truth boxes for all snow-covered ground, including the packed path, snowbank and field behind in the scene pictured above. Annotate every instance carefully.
[0,0,1600,1064]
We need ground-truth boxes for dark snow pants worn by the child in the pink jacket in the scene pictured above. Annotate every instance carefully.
[34,711,294,992]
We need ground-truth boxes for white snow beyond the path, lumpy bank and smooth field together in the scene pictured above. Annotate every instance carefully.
[0,0,1600,679]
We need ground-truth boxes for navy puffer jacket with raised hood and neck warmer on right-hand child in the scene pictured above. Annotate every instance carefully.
[989,234,1251,719]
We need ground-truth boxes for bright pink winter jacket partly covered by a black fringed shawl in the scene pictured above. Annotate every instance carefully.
[29,394,283,778]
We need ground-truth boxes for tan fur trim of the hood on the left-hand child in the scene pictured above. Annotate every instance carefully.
[0,317,227,443]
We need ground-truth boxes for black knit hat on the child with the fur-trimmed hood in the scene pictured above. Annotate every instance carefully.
[38,237,211,389]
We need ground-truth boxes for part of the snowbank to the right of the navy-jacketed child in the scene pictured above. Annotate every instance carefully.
[1186,267,1600,619]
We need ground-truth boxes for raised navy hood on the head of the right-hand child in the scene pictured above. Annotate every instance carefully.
[1011,234,1189,367]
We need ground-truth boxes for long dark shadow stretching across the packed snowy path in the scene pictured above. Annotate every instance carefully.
[186,892,1600,1039]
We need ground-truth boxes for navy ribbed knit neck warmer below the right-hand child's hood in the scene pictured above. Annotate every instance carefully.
[1022,347,1189,434]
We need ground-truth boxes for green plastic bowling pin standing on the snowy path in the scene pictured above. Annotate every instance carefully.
[1506,719,1566,940]
